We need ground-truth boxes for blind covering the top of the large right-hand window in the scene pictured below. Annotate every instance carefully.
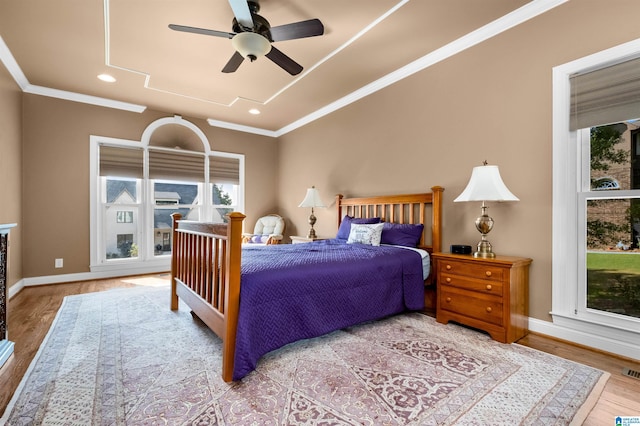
[570,58,640,130]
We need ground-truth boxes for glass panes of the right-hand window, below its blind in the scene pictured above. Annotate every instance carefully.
[578,123,640,318]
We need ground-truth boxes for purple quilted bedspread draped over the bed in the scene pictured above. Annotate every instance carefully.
[233,240,424,380]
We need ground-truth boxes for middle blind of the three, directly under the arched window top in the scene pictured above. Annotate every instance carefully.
[149,149,204,182]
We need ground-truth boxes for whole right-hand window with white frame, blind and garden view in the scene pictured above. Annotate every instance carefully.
[551,40,640,356]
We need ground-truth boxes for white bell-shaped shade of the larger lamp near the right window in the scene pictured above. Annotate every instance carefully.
[453,165,520,202]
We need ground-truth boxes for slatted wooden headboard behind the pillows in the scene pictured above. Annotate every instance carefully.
[336,186,444,253]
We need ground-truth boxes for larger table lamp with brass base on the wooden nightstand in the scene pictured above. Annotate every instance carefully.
[453,161,520,258]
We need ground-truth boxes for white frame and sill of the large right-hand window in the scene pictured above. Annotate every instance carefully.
[550,39,640,359]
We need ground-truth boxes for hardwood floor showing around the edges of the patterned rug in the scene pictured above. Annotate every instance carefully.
[0,274,640,426]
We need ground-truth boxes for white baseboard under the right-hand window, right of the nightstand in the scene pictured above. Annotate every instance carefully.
[529,318,640,361]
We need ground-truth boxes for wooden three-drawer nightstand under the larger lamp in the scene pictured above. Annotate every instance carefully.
[432,253,531,343]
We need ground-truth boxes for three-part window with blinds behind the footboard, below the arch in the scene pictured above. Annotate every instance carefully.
[91,118,244,273]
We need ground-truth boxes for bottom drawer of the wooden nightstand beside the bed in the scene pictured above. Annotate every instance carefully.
[438,286,503,326]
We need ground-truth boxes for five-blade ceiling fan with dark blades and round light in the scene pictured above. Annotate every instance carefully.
[169,0,324,75]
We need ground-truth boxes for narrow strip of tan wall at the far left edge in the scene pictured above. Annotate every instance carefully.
[0,64,23,287]
